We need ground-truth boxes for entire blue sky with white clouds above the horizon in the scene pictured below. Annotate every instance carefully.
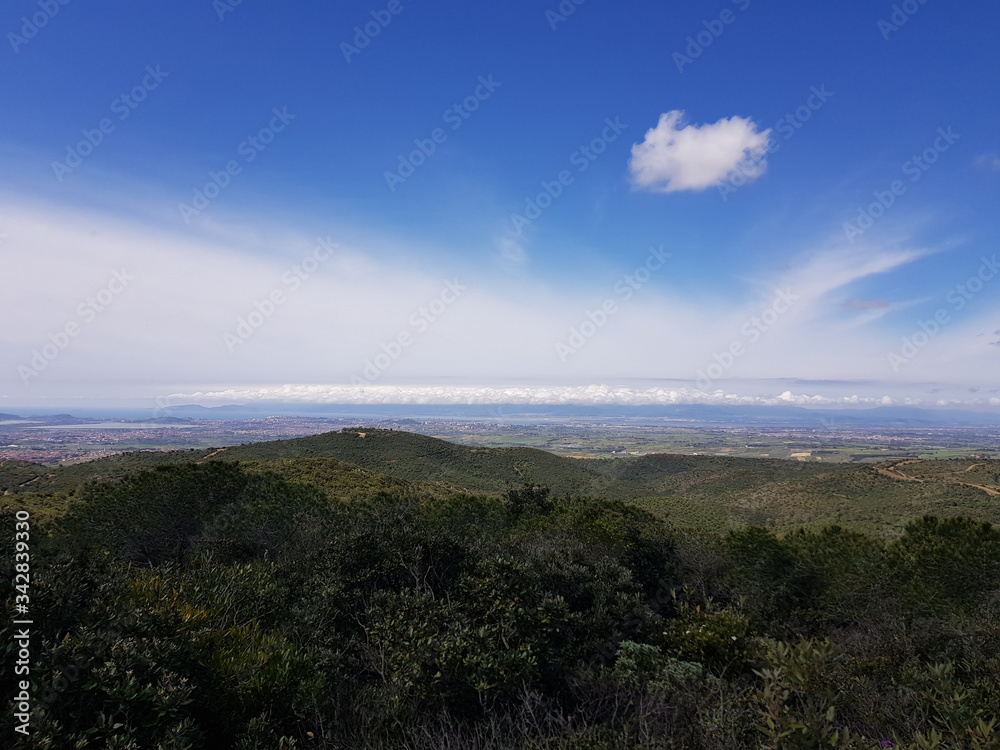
[0,0,1000,409]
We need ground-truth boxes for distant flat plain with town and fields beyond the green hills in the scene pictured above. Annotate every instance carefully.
[0,414,1000,465]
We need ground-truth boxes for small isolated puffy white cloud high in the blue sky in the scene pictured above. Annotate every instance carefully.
[629,110,771,193]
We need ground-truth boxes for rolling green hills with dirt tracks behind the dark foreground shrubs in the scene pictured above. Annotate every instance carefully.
[0,429,1000,535]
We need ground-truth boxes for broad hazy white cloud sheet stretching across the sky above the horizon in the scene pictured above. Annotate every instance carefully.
[0,194,998,411]
